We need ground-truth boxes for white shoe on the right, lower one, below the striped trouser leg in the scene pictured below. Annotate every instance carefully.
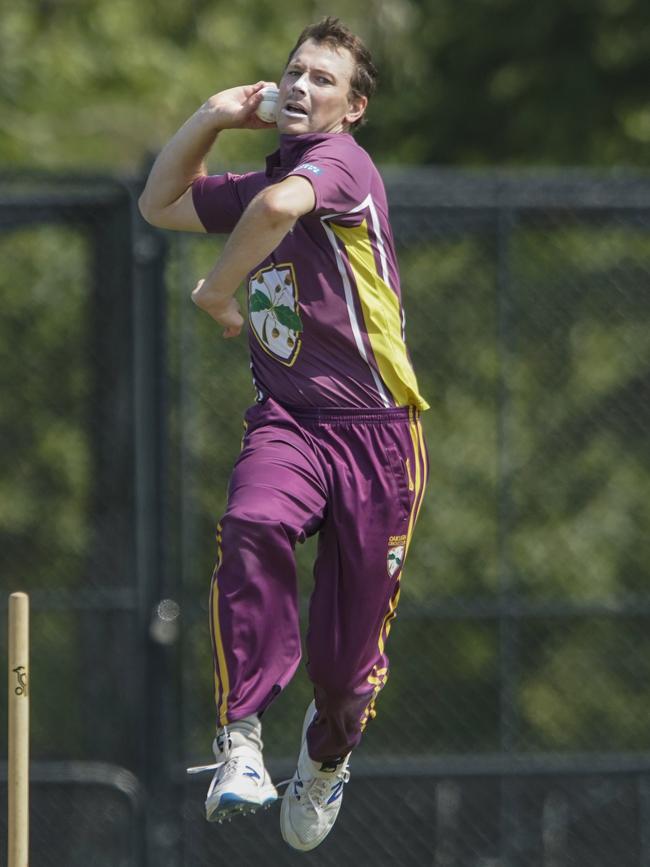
[280,702,350,852]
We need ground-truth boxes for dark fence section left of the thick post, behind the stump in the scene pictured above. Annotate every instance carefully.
[0,175,145,867]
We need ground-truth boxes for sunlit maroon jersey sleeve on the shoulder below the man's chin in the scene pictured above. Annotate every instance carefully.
[289,136,373,217]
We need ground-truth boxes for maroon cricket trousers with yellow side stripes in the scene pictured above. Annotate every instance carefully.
[210,399,428,761]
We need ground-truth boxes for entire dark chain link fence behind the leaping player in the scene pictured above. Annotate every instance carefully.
[0,171,650,867]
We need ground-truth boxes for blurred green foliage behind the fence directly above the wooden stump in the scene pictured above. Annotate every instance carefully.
[0,229,91,588]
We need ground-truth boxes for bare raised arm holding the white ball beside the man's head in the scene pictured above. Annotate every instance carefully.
[138,81,270,232]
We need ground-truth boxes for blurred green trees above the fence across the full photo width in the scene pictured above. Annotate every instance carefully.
[0,0,650,170]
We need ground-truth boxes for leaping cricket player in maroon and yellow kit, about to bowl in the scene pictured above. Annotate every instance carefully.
[140,18,427,851]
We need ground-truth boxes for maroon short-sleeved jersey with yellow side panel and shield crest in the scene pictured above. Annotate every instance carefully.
[193,133,427,409]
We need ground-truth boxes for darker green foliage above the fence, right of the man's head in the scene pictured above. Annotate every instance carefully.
[364,0,650,166]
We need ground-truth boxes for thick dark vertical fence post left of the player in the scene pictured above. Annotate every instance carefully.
[133,193,182,867]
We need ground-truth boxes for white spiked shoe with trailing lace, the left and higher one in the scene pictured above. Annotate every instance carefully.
[187,716,278,823]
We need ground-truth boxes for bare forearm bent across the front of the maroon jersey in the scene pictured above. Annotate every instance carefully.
[192,175,316,337]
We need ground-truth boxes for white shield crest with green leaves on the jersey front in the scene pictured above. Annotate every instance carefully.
[248,263,303,367]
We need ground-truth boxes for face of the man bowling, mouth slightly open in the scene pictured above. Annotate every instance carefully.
[277,39,368,135]
